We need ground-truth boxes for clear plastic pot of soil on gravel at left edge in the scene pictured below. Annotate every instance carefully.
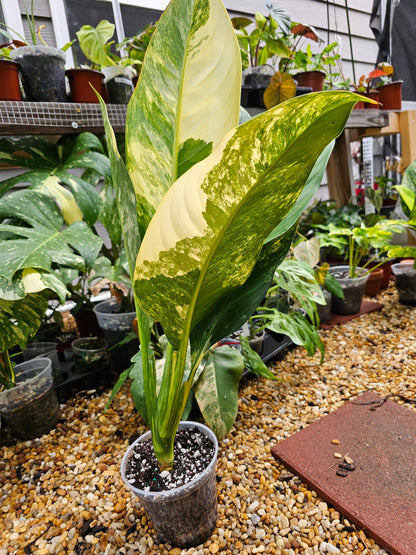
[0,358,60,440]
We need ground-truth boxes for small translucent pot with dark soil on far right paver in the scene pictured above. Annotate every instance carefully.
[329,266,368,315]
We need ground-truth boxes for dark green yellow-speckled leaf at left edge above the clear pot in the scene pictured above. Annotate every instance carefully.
[0,293,48,352]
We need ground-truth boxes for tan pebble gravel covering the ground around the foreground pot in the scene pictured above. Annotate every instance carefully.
[0,287,416,555]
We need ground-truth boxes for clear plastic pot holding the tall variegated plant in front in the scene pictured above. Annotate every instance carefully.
[121,422,218,548]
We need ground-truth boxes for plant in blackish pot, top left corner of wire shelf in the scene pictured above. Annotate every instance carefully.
[1,0,66,102]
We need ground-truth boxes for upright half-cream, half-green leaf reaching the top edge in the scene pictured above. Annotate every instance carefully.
[126,0,241,233]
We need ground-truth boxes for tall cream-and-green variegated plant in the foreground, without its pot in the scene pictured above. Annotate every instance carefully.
[98,0,359,468]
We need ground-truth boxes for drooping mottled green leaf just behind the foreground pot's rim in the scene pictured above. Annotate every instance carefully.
[195,346,244,439]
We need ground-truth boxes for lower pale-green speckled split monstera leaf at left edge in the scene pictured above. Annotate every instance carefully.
[0,190,102,281]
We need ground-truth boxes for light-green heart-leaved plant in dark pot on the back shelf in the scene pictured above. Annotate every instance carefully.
[76,19,134,104]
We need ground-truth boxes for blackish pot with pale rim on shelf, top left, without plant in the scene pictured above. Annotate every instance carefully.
[10,46,66,102]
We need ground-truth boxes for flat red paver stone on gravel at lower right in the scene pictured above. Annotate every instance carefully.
[272,391,416,555]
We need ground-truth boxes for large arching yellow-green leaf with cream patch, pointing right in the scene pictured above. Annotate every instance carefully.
[135,91,357,347]
